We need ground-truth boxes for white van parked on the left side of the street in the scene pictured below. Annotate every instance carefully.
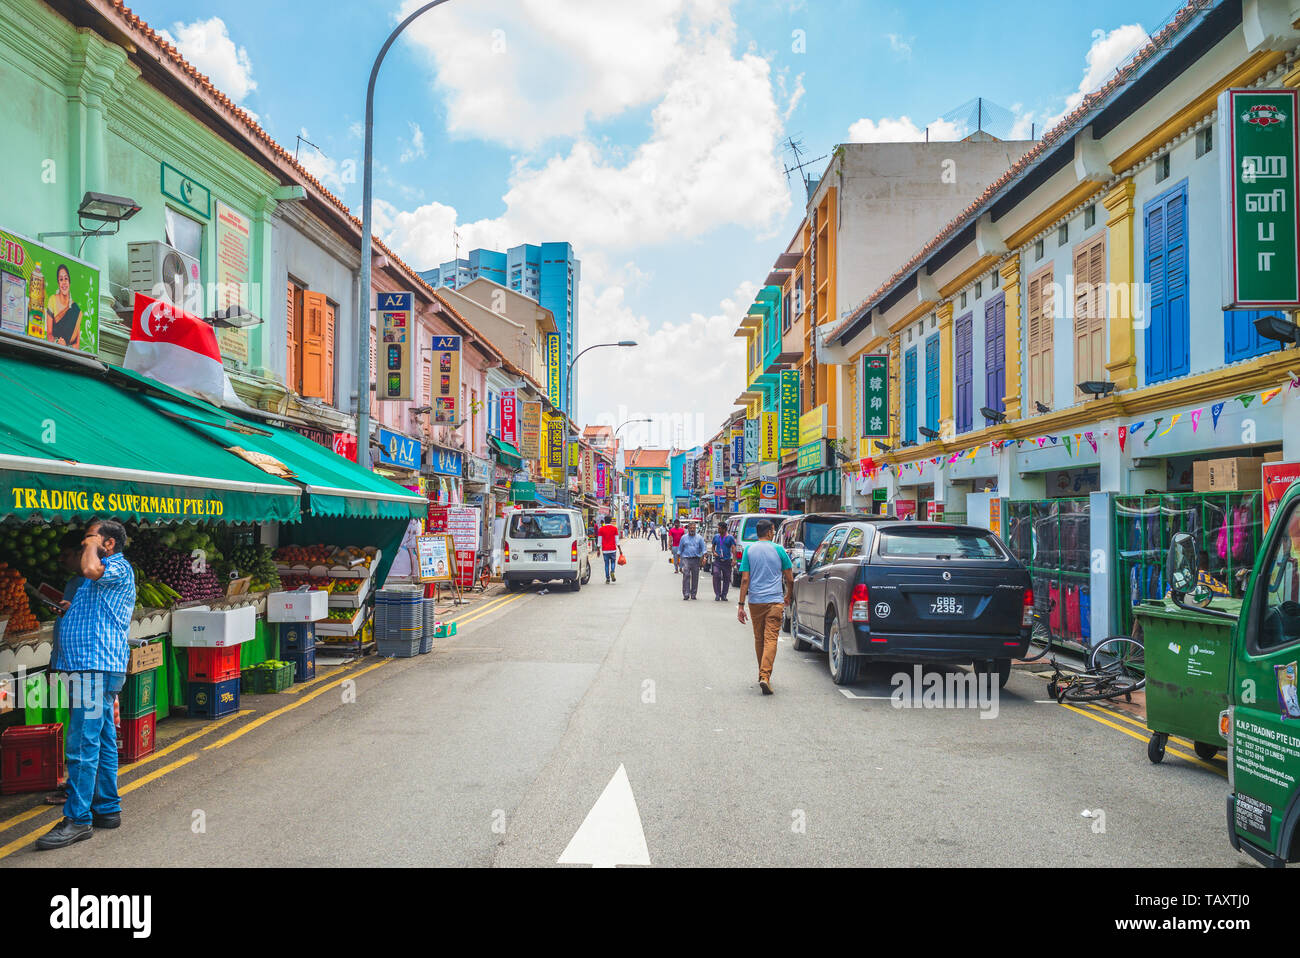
[502,508,592,591]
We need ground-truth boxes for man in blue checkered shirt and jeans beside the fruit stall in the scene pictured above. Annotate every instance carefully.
[36,519,135,849]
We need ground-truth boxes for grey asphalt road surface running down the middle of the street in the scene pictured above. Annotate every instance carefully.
[0,541,1253,867]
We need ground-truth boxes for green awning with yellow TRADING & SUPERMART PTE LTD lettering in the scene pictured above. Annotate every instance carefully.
[0,356,302,523]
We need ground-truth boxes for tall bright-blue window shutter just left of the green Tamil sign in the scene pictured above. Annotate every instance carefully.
[1143,181,1191,383]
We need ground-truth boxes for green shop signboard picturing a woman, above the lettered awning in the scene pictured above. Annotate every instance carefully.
[0,230,99,355]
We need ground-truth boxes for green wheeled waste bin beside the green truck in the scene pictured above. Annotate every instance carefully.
[1134,597,1242,762]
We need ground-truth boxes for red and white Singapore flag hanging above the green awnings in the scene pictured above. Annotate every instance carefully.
[124,292,247,408]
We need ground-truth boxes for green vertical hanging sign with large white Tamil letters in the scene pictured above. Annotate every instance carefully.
[1218,90,1300,309]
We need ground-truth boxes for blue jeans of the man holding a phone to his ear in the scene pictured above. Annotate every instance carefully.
[64,672,126,825]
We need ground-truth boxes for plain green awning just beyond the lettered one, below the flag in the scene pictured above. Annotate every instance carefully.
[134,392,429,519]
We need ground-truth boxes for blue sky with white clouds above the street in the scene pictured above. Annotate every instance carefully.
[131,0,1177,446]
